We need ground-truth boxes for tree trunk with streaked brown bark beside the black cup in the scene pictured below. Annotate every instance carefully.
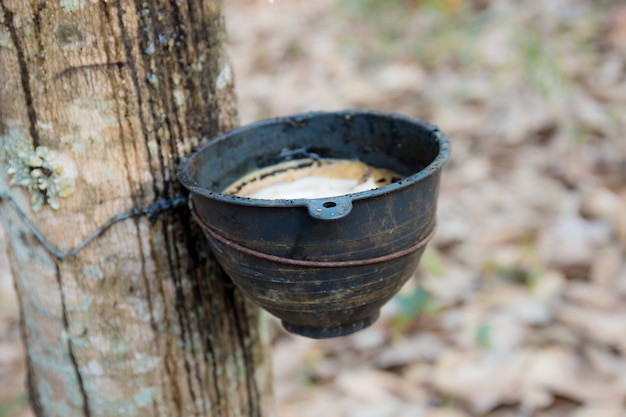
[0,0,272,417]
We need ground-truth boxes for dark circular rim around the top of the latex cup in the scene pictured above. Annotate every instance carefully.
[178,110,450,210]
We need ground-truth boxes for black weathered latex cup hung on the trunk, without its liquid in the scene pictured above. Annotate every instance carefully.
[179,111,449,338]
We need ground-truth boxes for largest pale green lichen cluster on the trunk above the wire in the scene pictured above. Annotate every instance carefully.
[0,129,74,212]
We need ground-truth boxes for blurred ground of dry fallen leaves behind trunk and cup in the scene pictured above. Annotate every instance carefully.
[0,0,626,417]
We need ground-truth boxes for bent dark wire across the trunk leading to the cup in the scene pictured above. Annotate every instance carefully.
[0,192,187,260]
